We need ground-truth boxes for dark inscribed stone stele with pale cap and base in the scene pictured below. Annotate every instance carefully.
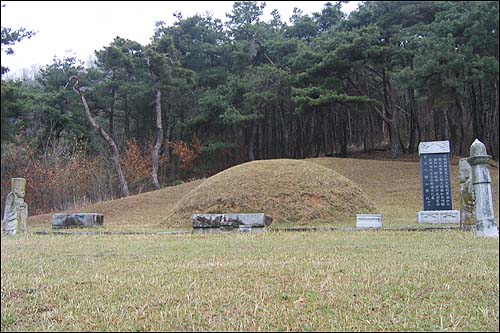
[417,141,460,223]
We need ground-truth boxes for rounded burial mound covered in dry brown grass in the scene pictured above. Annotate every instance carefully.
[162,159,377,226]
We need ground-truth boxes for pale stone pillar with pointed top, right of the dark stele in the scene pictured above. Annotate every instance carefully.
[467,139,498,238]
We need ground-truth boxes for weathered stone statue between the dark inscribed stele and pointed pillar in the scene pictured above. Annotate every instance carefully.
[458,158,476,230]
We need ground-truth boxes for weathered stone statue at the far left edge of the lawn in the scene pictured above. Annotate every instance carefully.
[2,178,28,235]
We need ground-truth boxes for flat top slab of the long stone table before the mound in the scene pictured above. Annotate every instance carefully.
[191,213,273,228]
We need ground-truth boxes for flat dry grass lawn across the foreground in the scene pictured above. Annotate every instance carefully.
[1,231,499,331]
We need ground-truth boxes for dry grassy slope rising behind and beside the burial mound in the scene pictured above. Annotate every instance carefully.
[29,157,499,230]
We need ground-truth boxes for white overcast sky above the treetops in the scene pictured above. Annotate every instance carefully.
[1,1,360,77]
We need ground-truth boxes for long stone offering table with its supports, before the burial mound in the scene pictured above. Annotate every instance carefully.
[191,213,273,233]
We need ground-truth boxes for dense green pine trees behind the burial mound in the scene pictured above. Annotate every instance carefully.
[1,1,499,210]
